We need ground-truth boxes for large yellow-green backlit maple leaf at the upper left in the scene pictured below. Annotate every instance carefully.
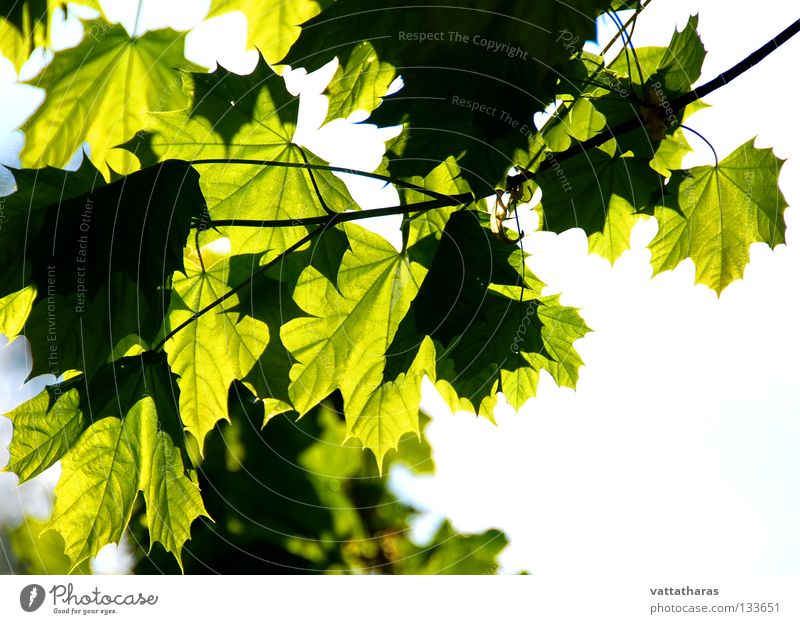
[20,20,193,177]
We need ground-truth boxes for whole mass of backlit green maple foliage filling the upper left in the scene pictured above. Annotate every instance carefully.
[0,0,796,572]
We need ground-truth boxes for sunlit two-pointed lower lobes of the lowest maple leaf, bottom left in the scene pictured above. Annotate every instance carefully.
[45,398,207,567]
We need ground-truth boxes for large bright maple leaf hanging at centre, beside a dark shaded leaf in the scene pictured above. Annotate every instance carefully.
[281,225,426,462]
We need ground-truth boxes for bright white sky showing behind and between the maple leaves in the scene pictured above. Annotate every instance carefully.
[0,0,800,579]
